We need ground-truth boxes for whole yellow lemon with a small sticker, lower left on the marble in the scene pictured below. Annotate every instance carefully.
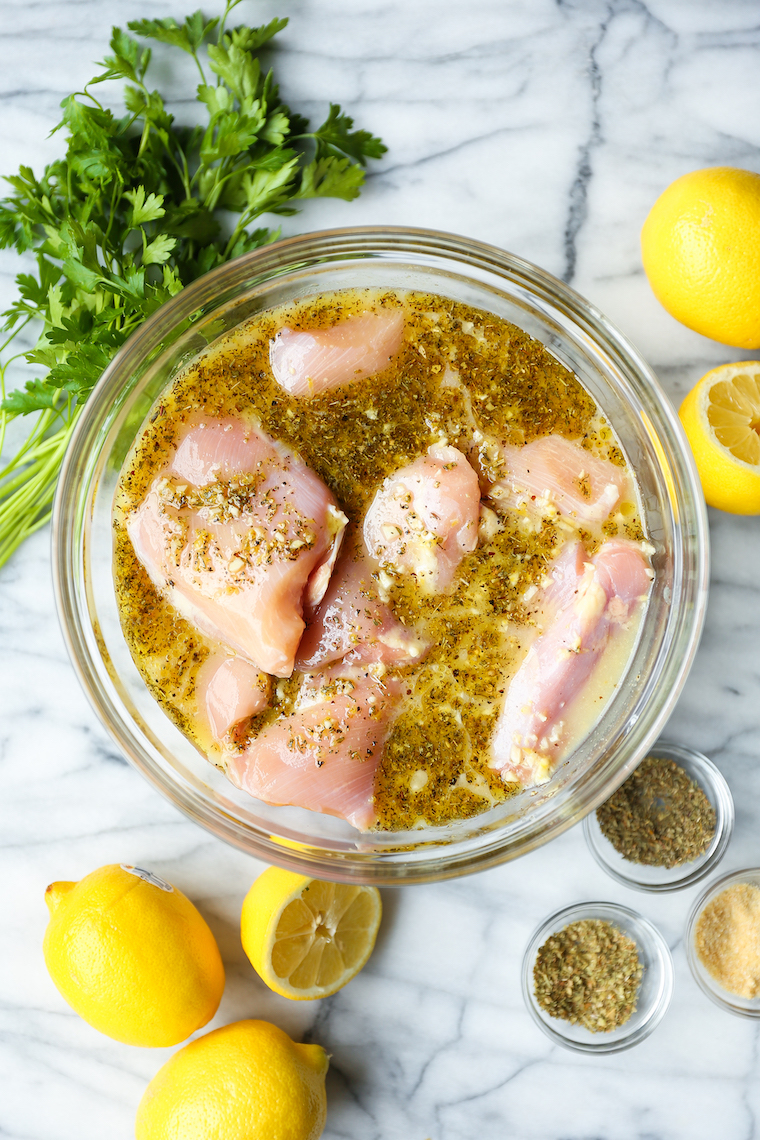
[43,863,224,1045]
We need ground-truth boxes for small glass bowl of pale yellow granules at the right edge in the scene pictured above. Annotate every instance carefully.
[685,868,760,1017]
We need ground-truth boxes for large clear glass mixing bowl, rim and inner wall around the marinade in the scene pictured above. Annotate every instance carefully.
[54,227,708,884]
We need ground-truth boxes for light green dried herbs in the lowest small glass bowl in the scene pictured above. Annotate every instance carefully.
[533,919,644,1033]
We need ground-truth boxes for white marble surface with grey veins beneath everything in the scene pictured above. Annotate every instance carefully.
[0,0,760,1140]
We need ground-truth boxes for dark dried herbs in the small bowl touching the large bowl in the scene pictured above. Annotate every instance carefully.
[596,756,716,868]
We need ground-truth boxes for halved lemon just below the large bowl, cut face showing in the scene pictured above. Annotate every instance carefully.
[240,866,383,1001]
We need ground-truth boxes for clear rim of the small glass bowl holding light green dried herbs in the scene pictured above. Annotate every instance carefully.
[521,899,675,1055]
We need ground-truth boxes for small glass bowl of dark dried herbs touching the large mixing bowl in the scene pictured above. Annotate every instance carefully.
[583,741,734,891]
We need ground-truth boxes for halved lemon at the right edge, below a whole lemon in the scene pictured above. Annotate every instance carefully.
[679,360,760,514]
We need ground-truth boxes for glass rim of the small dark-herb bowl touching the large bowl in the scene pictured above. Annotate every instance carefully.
[583,738,736,894]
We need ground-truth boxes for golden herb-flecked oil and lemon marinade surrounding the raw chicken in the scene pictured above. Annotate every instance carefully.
[114,290,645,830]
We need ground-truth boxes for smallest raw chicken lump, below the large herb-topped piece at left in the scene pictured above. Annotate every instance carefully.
[195,653,271,743]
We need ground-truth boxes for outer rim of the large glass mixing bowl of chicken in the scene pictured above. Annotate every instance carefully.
[52,226,709,885]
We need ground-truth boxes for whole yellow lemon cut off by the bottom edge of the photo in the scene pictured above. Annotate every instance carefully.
[134,1021,329,1140]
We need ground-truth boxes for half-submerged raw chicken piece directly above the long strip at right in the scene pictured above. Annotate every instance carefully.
[489,435,634,522]
